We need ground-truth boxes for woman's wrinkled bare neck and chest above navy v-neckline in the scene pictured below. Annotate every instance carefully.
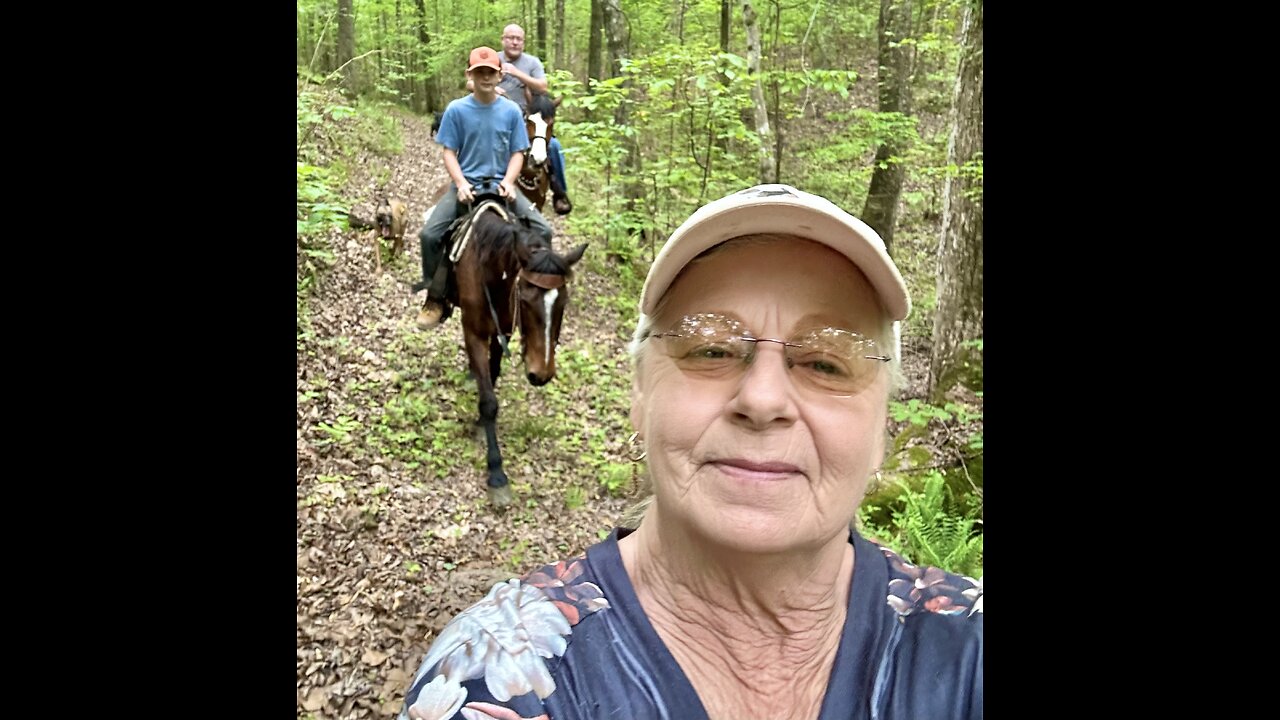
[618,509,854,719]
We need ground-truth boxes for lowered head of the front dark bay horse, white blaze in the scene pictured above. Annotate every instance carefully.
[516,220,586,387]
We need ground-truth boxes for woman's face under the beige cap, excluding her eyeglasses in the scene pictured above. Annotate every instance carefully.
[631,240,888,552]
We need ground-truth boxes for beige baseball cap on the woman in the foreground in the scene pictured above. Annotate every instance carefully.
[640,184,911,320]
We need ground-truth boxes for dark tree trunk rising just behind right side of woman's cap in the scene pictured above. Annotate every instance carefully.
[863,0,915,255]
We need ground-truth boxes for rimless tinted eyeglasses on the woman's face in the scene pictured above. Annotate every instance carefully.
[649,313,891,397]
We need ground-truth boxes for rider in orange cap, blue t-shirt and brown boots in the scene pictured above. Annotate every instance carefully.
[417,47,552,329]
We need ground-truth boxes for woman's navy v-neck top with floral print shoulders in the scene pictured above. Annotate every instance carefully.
[399,529,983,720]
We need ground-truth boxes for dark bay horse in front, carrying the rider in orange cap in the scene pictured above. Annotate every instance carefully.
[449,196,586,507]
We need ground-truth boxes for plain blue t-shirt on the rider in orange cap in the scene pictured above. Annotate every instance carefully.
[435,95,529,184]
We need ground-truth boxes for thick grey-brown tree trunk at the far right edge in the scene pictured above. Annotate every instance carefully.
[929,0,983,400]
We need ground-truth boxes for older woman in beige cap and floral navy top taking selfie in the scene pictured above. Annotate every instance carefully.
[401,184,983,720]
